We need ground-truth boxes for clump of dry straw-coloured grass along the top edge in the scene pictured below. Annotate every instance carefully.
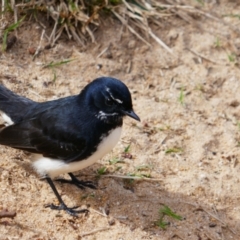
[0,0,218,54]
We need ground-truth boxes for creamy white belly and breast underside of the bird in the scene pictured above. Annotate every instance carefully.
[33,127,122,177]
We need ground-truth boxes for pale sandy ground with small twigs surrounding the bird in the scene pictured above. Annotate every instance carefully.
[0,1,240,240]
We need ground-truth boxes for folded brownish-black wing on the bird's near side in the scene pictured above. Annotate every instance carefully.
[0,104,87,161]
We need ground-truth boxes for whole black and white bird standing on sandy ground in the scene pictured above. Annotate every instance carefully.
[0,77,140,215]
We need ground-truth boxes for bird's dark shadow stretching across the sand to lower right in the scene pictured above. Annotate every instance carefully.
[39,164,240,239]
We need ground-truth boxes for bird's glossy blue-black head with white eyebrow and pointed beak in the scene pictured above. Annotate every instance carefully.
[83,77,140,121]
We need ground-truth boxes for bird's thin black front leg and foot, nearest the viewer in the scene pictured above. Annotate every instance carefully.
[45,176,88,216]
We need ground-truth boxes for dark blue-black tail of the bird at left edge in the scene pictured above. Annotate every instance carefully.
[0,85,36,123]
